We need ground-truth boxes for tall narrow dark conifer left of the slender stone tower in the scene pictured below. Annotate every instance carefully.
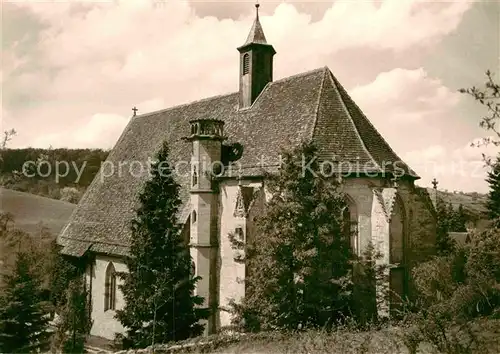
[117,143,208,348]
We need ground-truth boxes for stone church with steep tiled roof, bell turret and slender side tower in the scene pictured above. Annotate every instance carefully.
[58,5,436,339]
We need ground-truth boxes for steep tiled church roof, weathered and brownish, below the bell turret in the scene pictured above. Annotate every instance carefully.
[59,67,415,255]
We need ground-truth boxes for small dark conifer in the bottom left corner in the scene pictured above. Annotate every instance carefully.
[0,251,49,353]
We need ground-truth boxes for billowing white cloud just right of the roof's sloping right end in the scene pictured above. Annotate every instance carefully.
[350,68,462,173]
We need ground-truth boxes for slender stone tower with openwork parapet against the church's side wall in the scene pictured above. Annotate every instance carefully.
[185,119,225,335]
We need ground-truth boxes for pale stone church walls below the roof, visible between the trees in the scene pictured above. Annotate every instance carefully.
[87,178,436,340]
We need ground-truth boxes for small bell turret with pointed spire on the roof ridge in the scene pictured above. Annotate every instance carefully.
[238,4,276,109]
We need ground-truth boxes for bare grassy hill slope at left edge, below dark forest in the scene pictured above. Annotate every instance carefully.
[0,187,76,237]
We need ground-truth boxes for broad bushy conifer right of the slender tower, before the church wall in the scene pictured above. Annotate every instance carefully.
[233,144,352,331]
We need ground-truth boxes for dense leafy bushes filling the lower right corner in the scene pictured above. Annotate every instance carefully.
[407,228,500,353]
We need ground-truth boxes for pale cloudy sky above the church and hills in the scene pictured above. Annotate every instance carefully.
[0,0,500,192]
